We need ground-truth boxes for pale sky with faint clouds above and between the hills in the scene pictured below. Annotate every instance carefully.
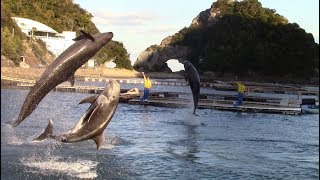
[74,0,319,71]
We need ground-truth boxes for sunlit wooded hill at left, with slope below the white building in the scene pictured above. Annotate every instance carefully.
[1,0,132,69]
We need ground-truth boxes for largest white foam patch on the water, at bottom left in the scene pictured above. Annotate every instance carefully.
[20,156,98,179]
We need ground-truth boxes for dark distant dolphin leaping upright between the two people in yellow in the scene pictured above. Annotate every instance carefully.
[183,61,200,115]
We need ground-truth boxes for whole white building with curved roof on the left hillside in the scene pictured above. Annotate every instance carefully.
[13,17,76,57]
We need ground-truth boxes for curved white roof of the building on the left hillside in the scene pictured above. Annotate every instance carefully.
[12,17,58,33]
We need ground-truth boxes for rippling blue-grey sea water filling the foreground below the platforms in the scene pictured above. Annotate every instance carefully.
[1,84,319,180]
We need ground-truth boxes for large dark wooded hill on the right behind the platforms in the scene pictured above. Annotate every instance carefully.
[134,0,319,83]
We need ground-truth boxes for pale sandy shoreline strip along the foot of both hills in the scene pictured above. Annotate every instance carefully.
[1,67,319,87]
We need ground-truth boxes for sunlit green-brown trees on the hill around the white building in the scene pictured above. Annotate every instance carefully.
[1,0,132,69]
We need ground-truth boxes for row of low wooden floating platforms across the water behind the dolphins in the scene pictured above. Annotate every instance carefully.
[1,77,314,115]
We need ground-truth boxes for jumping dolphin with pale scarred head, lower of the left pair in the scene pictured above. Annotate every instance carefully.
[33,80,120,150]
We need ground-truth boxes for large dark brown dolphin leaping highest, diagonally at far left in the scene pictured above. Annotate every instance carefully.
[11,31,113,127]
